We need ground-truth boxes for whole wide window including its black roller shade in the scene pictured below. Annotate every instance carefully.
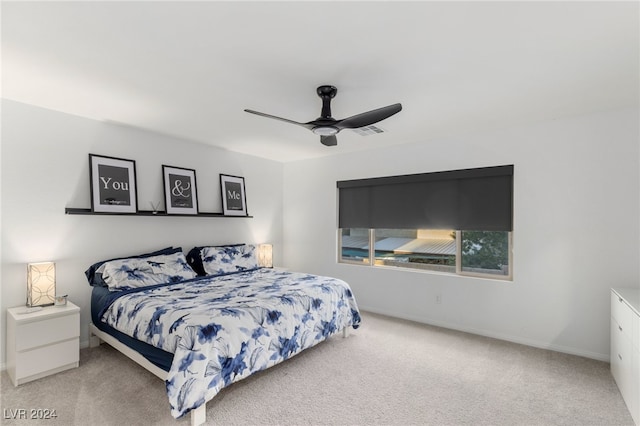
[337,166,513,279]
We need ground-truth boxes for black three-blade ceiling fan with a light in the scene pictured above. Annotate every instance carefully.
[245,85,402,146]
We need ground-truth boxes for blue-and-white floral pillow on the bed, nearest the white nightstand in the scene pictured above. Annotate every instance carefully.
[97,252,196,291]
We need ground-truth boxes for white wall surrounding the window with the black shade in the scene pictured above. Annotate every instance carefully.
[284,110,640,360]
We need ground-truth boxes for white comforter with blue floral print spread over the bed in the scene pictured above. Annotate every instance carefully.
[102,269,360,418]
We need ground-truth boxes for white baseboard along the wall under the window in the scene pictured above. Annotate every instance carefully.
[360,306,610,362]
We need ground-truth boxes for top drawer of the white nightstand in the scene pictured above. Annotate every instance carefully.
[15,313,80,352]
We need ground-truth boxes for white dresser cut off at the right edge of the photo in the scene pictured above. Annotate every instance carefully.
[611,288,640,425]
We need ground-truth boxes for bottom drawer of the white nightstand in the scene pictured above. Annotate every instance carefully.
[16,338,80,381]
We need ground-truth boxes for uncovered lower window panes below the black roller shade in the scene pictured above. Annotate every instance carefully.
[340,228,510,278]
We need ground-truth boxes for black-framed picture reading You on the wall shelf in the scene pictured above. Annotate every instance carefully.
[89,154,138,213]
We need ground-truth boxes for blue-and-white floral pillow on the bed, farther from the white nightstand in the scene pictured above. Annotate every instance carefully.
[200,244,258,275]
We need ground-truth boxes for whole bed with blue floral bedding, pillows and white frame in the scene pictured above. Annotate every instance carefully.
[86,244,360,424]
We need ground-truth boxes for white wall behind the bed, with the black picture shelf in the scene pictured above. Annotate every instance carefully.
[0,100,283,363]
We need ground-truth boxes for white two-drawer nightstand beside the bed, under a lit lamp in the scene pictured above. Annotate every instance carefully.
[7,302,80,386]
